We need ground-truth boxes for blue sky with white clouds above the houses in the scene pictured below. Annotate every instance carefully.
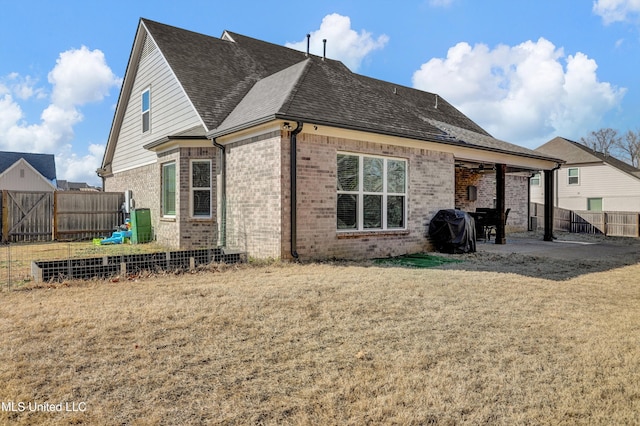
[0,0,640,184]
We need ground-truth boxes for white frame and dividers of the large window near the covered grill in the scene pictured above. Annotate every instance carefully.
[336,151,409,234]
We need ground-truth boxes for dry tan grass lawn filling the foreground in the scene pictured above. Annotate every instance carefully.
[0,255,640,425]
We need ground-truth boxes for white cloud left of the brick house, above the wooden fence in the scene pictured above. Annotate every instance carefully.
[0,46,121,183]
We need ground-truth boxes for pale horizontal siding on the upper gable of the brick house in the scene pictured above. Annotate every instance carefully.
[112,35,202,172]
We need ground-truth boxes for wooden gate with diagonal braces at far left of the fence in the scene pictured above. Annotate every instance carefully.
[0,190,53,242]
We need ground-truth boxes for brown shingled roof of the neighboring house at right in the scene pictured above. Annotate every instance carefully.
[536,136,640,178]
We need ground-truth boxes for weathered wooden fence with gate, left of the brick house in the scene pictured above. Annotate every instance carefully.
[0,190,124,242]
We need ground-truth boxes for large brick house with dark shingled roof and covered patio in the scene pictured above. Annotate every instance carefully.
[98,19,558,259]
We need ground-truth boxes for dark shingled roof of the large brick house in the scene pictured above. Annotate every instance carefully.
[103,19,555,171]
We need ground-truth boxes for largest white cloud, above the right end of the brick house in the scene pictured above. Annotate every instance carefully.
[413,38,625,147]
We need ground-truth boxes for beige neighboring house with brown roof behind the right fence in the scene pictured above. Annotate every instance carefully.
[531,137,640,212]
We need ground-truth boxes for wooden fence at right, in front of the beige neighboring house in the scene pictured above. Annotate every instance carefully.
[530,203,640,237]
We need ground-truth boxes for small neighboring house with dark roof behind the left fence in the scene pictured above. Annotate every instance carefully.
[0,151,56,192]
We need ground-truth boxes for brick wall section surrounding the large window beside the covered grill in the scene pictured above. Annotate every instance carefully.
[297,133,454,259]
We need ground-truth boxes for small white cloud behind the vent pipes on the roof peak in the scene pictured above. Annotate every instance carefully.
[286,13,389,71]
